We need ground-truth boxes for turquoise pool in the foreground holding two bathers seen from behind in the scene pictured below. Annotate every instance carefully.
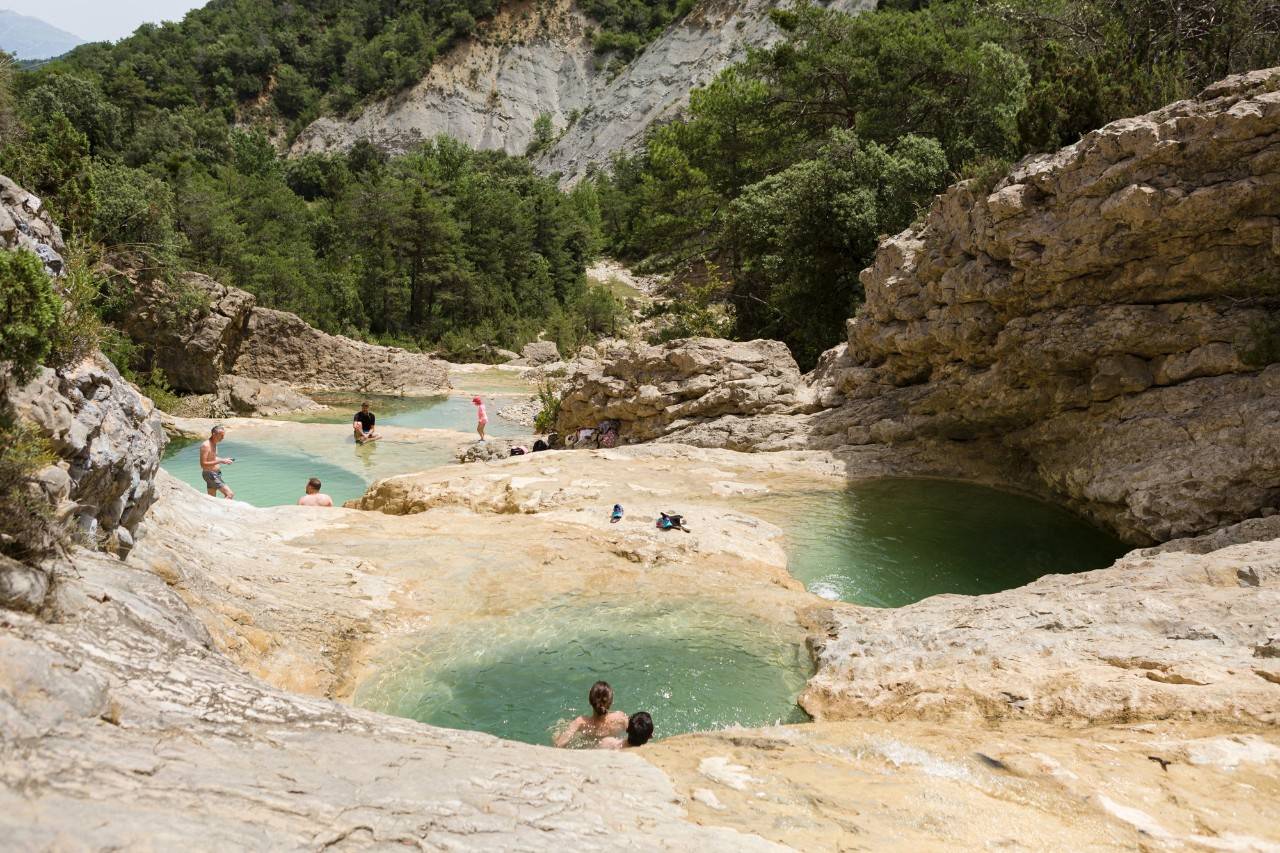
[353,602,813,744]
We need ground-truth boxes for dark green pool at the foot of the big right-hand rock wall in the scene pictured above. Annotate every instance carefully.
[745,479,1128,607]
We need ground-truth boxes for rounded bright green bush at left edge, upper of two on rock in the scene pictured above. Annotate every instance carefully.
[0,250,63,386]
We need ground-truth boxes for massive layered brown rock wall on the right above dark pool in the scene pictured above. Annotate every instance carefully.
[815,69,1280,540]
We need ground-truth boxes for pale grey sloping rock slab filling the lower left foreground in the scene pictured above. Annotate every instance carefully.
[0,522,780,850]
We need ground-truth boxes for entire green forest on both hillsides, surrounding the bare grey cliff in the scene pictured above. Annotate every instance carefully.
[0,0,1280,379]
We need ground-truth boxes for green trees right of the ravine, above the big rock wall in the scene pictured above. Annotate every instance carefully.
[594,0,1280,366]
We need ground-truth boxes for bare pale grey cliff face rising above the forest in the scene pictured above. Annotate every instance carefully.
[293,0,874,179]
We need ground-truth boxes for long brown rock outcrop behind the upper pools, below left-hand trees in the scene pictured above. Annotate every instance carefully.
[125,273,449,394]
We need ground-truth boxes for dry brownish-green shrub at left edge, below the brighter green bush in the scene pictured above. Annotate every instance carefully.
[0,411,65,560]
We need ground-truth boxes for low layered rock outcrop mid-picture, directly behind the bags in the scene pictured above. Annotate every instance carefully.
[557,338,814,440]
